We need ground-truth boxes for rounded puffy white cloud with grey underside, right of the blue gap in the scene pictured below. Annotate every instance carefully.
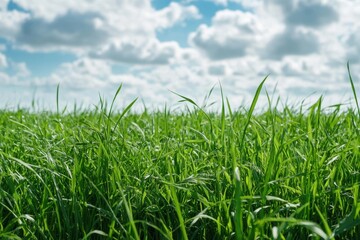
[189,10,265,60]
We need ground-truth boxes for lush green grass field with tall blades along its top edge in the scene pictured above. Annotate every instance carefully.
[0,67,360,239]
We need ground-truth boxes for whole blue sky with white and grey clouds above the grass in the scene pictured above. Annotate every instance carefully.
[0,0,360,108]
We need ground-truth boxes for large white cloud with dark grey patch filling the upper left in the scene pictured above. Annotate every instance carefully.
[5,0,201,68]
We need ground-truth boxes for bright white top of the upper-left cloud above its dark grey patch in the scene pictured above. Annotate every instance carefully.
[10,0,201,34]
